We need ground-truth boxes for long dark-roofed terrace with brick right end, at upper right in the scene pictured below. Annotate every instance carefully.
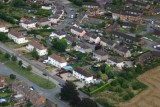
[110,31,144,44]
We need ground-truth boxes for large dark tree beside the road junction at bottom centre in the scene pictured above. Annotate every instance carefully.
[60,81,79,102]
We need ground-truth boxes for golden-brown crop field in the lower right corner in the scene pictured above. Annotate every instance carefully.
[118,66,160,107]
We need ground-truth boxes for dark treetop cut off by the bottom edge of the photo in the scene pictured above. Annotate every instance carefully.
[77,98,98,107]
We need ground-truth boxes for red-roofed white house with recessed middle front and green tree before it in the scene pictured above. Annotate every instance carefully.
[26,40,48,56]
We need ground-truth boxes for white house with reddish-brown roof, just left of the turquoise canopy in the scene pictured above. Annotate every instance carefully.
[48,54,67,68]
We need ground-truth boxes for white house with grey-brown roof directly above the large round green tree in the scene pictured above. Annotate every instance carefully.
[49,30,66,39]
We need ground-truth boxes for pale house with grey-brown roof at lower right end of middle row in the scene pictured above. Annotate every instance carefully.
[106,56,125,69]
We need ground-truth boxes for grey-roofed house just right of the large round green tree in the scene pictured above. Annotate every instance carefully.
[74,43,92,53]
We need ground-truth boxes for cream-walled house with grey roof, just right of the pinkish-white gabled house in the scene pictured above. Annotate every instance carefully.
[100,37,115,49]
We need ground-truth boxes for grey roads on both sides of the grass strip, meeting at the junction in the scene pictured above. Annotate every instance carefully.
[0,43,88,107]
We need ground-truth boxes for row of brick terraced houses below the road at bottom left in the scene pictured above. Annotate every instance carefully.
[12,80,46,107]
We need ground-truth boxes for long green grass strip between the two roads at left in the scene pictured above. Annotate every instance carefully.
[6,61,56,89]
